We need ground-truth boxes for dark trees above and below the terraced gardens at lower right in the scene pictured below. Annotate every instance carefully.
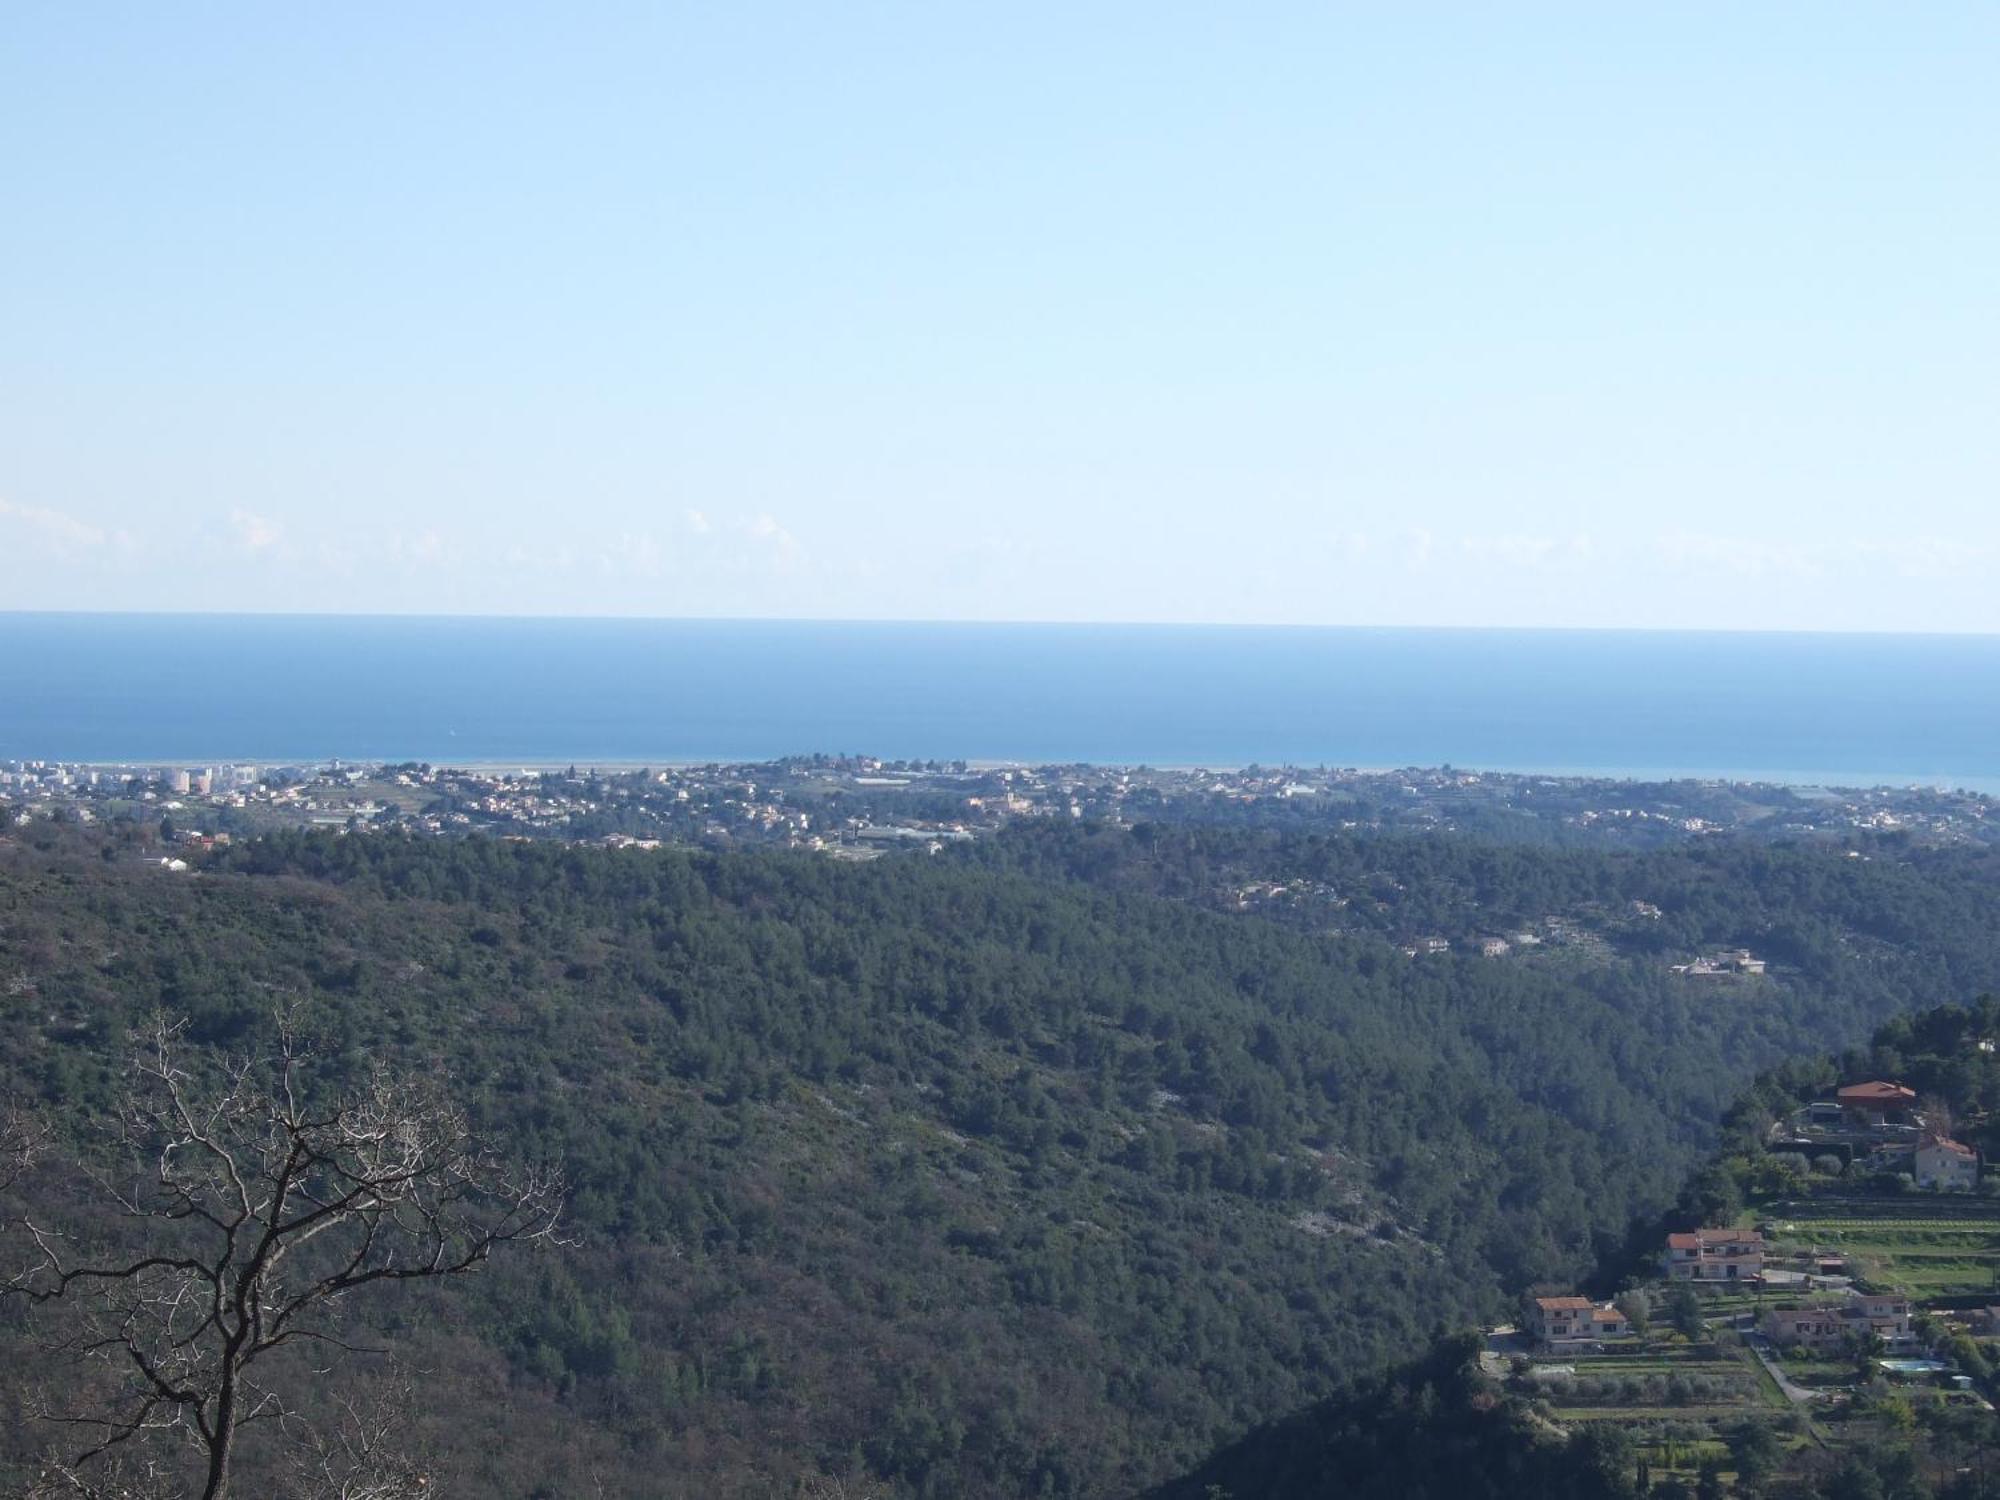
[1148,996,2000,1500]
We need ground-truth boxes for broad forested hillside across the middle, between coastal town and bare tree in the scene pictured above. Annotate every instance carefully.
[0,826,2000,1496]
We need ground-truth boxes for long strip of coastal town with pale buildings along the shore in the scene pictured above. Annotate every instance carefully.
[0,756,2000,858]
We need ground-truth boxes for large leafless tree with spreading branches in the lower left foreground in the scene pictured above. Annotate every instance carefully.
[0,1016,562,1500]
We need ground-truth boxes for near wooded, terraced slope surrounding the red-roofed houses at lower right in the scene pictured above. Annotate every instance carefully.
[1148,994,2000,1500]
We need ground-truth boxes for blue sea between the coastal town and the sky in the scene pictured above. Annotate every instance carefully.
[0,612,2000,794]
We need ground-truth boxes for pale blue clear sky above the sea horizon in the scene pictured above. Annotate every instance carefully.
[0,0,2000,632]
